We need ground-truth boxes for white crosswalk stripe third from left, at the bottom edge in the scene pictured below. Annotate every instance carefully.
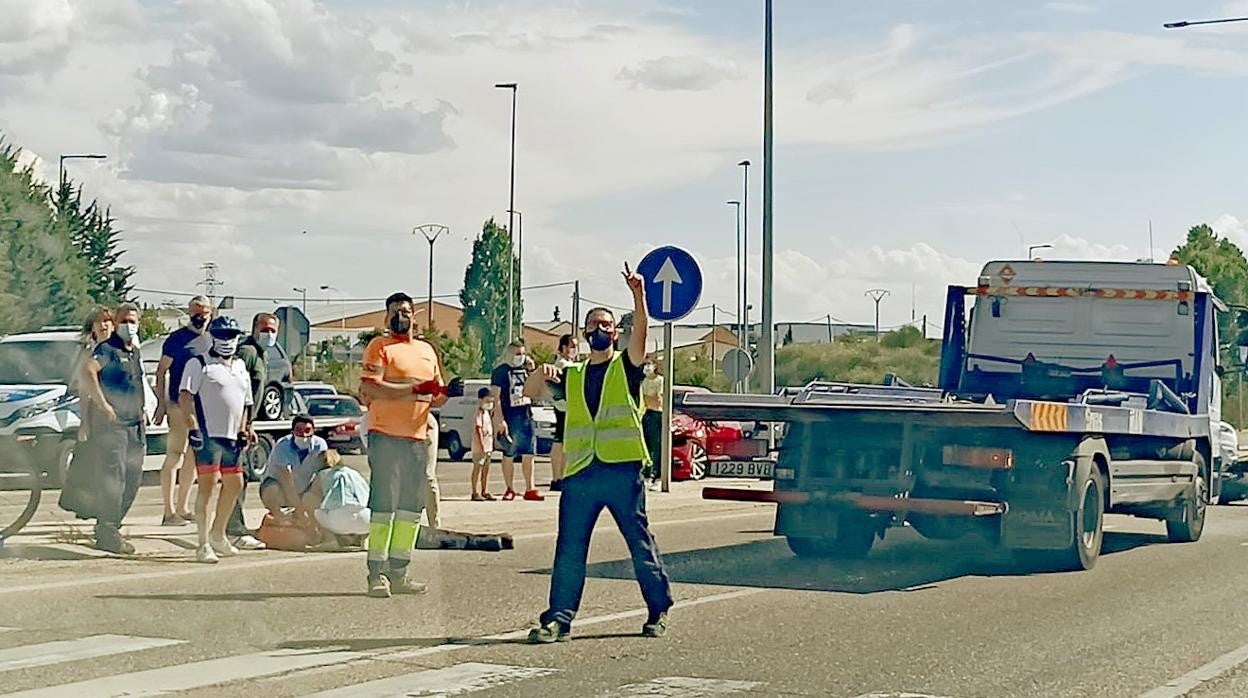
[308,662,558,698]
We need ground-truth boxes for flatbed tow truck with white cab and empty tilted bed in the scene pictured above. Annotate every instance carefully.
[678,260,1228,569]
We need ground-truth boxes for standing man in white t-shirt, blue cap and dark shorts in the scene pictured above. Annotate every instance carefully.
[178,317,256,563]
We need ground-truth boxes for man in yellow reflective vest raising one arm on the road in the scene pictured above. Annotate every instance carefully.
[525,265,671,643]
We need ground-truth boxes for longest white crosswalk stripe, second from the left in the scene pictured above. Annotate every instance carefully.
[9,649,368,698]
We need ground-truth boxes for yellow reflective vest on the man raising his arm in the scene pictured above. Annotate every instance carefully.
[563,352,650,476]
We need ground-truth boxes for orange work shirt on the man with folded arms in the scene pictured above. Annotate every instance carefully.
[364,335,442,441]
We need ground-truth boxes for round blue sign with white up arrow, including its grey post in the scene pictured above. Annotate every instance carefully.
[636,246,701,492]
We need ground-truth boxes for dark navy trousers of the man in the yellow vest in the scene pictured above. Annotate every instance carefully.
[540,463,671,627]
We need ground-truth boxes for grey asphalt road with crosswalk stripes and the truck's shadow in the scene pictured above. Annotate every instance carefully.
[0,463,1248,698]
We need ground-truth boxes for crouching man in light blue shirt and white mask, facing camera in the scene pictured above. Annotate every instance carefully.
[260,415,329,521]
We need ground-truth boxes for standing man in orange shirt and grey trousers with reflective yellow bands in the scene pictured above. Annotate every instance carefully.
[359,292,447,598]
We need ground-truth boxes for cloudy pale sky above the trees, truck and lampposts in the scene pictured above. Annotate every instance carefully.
[0,0,1248,325]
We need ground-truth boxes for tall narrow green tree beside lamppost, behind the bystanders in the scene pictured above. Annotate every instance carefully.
[459,217,524,371]
